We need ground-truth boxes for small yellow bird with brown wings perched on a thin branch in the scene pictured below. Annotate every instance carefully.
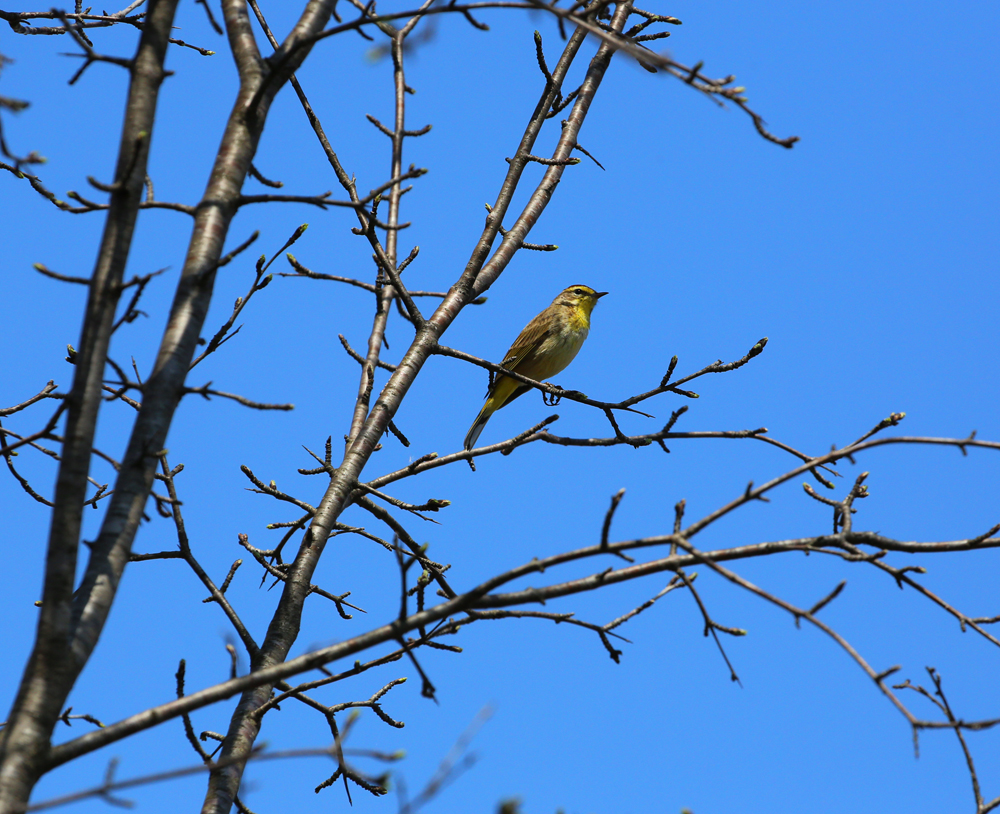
[465,285,608,449]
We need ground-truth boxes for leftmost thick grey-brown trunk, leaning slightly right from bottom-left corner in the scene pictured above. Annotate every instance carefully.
[0,0,177,810]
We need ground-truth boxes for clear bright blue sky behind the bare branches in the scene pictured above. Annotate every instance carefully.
[0,0,1000,814]
